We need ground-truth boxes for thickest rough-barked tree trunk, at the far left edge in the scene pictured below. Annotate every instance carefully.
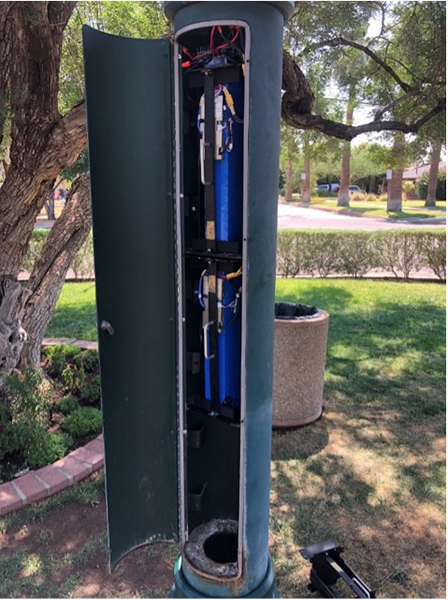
[0,2,87,377]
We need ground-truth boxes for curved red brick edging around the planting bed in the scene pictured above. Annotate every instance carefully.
[0,338,104,516]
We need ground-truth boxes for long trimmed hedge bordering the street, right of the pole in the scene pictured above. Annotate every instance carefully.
[277,229,446,281]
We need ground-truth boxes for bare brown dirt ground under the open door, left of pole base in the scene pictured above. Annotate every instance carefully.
[0,486,178,598]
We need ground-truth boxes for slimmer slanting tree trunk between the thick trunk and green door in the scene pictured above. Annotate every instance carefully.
[20,173,91,367]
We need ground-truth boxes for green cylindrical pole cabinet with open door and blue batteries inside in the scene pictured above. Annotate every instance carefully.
[84,2,294,597]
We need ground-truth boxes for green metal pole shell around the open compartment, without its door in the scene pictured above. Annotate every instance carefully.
[165,2,294,597]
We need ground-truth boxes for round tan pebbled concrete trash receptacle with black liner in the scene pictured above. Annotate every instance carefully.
[272,302,329,427]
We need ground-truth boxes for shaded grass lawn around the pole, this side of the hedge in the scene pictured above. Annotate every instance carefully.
[7,279,445,598]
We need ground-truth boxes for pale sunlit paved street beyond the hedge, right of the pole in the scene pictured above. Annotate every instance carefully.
[278,203,446,231]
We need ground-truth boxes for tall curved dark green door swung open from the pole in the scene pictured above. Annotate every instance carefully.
[83,27,179,568]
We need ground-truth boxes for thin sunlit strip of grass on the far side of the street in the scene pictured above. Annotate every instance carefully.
[293,194,446,219]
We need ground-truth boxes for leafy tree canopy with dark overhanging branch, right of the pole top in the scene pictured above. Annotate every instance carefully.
[282,1,446,140]
